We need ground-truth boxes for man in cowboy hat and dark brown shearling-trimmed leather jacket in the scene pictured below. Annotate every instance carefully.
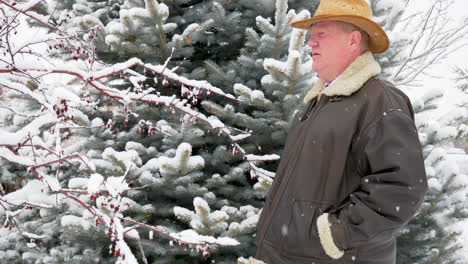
[256,0,427,264]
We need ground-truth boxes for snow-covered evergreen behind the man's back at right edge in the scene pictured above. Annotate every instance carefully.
[398,81,468,263]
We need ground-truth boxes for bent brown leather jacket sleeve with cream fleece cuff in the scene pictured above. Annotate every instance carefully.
[317,110,427,259]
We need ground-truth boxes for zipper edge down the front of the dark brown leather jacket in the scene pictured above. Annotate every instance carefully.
[259,98,327,248]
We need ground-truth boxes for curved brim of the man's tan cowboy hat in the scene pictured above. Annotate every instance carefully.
[291,15,390,53]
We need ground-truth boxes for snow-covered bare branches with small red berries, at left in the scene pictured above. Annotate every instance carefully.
[0,0,272,263]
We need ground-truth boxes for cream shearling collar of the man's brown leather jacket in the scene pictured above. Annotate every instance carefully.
[304,51,382,103]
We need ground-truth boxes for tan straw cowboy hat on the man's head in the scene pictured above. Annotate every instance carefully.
[291,0,390,53]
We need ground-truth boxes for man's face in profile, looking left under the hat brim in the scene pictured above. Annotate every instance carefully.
[308,21,349,82]
